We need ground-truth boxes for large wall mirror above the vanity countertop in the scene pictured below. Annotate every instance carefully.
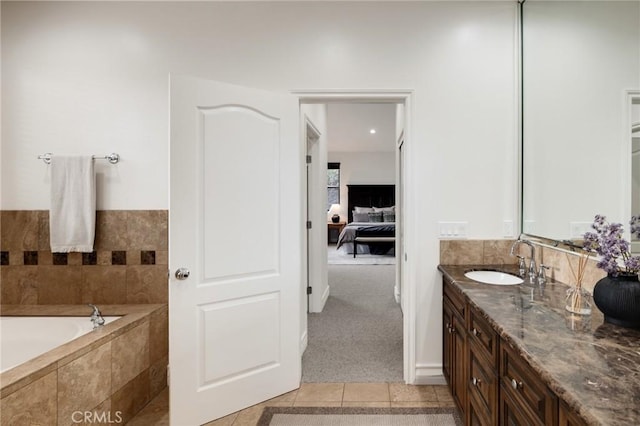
[522,0,640,252]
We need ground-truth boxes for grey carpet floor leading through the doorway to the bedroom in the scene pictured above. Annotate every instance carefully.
[302,265,403,383]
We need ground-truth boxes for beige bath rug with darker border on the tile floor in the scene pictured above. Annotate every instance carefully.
[258,407,462,426]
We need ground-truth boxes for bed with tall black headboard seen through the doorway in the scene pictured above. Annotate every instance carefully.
[336,185,396,257]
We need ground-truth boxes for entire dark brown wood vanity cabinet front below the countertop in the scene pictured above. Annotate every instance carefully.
[443,277,585,426]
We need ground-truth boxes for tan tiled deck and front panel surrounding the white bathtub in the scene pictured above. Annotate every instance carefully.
[0,304,168,425]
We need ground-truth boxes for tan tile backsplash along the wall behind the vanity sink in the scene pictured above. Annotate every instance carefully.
[440,240,606,291]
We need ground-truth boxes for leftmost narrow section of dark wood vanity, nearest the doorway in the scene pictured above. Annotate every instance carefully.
[442,283,467,407]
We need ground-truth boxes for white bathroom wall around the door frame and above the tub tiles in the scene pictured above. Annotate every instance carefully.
[1,1,518,380]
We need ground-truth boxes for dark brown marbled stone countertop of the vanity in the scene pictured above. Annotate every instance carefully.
[438,265,640,426]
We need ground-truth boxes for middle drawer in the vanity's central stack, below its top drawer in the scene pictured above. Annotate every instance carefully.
[467,340,499,424]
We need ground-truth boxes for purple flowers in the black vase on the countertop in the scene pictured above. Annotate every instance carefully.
[583,215,640,277]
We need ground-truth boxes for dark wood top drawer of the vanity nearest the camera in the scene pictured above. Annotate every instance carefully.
[500,342,558,425]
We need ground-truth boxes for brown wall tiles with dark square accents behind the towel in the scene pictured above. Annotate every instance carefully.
[0,210,168,305]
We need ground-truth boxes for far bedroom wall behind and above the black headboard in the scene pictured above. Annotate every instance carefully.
[329,151,396,222]
